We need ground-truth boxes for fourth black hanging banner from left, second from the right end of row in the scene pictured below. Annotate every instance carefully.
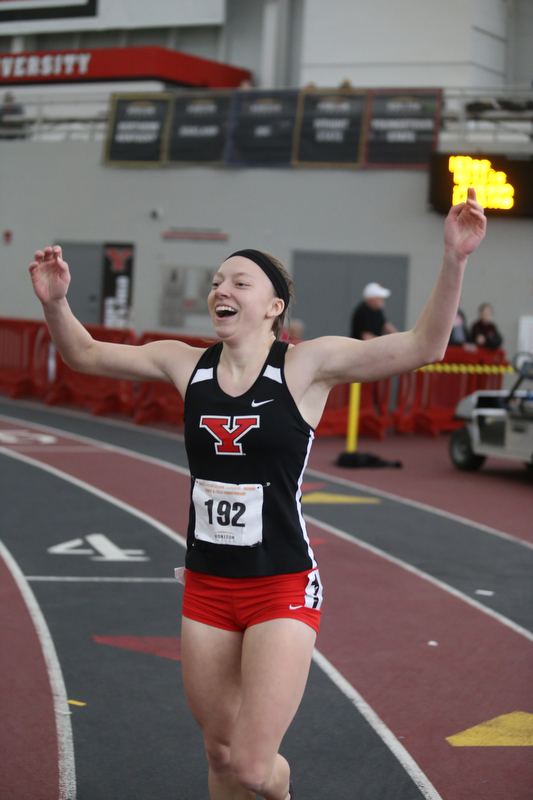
[294,89,367,167]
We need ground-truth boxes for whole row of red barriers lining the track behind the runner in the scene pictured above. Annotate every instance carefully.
[0,318,507,439]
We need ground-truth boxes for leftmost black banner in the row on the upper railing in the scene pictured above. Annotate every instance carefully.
[105,94,170,166]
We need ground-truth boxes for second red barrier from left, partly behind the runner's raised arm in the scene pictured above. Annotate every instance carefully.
[45,325,136,414]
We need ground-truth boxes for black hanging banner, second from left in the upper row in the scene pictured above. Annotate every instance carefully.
[168,91,233,164]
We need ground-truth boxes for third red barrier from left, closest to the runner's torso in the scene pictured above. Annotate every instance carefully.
[133,331,218,425]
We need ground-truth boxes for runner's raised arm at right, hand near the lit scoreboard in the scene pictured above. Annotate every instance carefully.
[290,189,486,386]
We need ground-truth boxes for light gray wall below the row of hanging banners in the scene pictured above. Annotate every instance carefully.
[0,141,533,352]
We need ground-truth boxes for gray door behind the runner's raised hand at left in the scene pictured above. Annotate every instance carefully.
[56,242,104,325]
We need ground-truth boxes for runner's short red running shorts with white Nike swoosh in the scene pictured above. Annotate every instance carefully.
[183,569,322,633]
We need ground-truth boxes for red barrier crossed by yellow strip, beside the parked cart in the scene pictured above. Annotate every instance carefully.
[393,347,507,436]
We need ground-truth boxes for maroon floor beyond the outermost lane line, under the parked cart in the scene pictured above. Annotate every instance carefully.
[309,435,533,548]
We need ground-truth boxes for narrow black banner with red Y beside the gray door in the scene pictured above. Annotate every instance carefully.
[102,244,135,328]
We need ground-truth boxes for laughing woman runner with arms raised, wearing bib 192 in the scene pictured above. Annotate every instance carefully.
[30,184,486,800]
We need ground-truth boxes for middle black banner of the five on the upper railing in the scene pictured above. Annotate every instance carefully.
[226,90,298,167]
